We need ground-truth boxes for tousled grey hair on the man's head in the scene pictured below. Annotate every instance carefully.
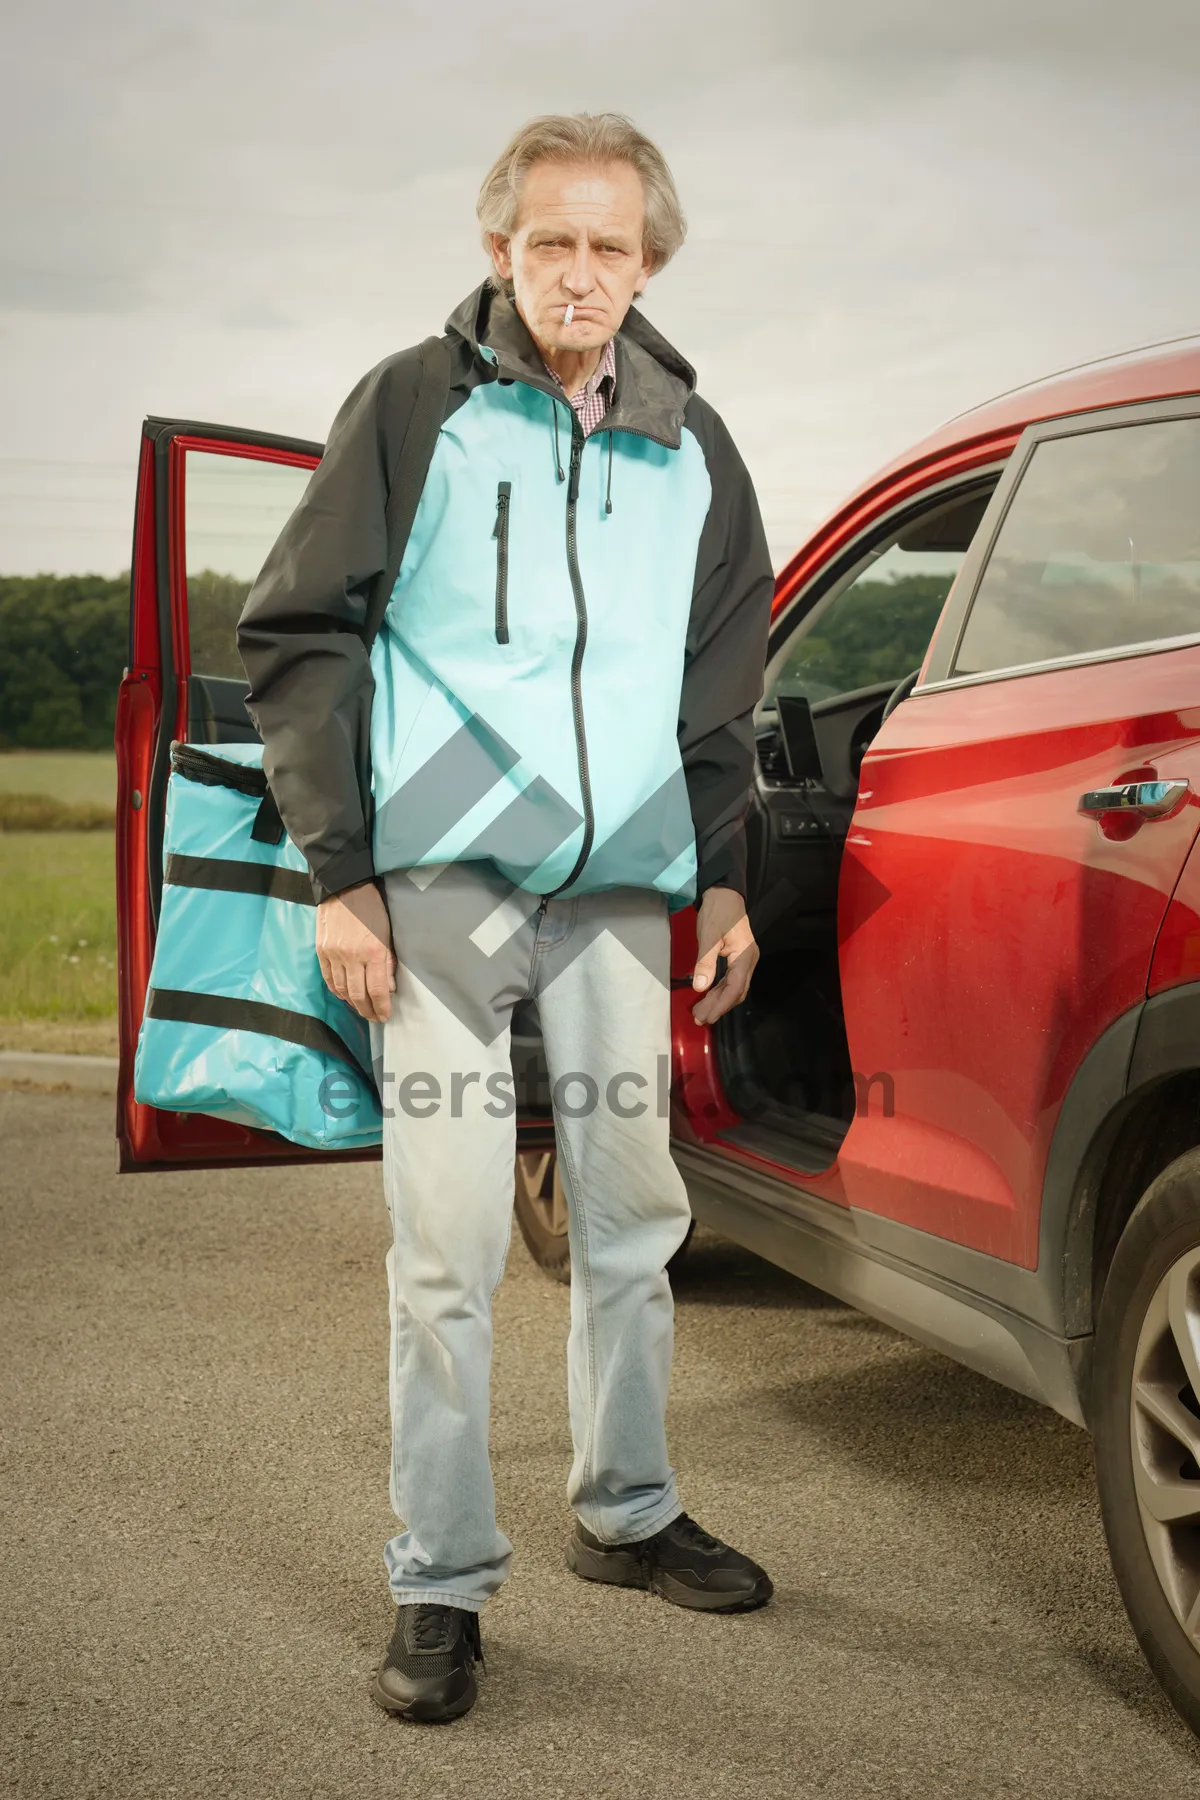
[475,113,687,288]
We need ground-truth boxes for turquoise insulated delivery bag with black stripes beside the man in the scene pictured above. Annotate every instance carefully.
[133,743,381,1150]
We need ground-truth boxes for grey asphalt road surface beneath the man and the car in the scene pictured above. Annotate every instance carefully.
[0,1093,1200,1800]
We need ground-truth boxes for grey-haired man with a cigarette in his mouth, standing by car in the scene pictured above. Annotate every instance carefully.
[239,113,774,1719]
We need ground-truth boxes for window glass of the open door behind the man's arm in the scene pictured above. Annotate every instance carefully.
[184,450,311,680]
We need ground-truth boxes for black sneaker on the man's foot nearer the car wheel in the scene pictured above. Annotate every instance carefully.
[567,1512,775,1613]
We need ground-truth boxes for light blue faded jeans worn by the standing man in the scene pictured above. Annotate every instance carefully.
[372,862,691,1611]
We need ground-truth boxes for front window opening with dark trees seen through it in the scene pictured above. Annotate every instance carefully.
[763,481,995,707]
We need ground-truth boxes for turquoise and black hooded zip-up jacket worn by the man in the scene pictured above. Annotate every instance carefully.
[237,284,774,909]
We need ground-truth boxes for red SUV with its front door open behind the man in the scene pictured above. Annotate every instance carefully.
[117,342,1200,1730]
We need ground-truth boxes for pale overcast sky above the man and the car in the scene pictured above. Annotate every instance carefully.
[0,0,1200,572]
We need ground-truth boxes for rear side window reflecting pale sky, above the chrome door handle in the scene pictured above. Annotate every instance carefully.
[952,419,1200,675]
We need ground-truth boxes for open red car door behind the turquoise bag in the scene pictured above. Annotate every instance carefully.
[115,419,380,1170]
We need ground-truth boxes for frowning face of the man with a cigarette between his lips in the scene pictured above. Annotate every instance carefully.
[491,162,651,349]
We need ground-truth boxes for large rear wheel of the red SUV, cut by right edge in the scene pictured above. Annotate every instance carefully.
[1092,1150,1200,1733]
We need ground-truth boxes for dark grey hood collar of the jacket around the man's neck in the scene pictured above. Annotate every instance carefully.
[446,281,696,450]
